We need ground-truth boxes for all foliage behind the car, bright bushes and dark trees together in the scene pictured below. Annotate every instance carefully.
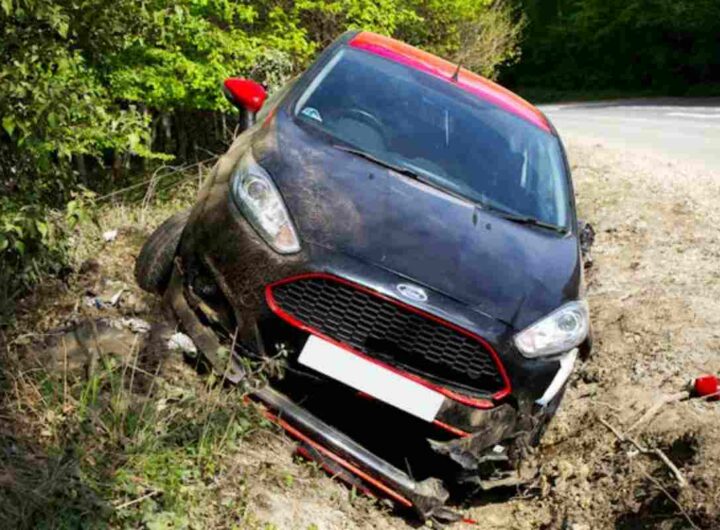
[0,0,720,314]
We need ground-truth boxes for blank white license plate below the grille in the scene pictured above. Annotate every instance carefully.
[298,335,445,422]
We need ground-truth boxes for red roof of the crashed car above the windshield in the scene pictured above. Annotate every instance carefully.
[348,31,553,133]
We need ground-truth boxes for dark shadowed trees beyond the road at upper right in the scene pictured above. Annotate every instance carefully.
[501,0,720,99]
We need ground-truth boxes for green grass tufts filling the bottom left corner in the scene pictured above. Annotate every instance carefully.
[0,324,264,528]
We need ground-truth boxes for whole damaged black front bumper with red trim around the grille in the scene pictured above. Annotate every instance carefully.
[166,186,574,518]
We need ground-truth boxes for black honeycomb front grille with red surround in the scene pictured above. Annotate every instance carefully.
[268,275,506,394]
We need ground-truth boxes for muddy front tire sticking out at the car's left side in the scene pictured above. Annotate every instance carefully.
[135,209,190,294]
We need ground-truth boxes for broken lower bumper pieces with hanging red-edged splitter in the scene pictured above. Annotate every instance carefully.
[165,252,574,522]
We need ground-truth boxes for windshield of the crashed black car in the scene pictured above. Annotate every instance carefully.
[294,48,569,228]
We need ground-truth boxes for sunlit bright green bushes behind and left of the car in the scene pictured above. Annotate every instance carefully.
[0,0,521,320]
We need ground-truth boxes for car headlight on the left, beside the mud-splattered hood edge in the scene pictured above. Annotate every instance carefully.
[231,151,300,254]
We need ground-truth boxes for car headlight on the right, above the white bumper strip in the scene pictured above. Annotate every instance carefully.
[515,300,590,358]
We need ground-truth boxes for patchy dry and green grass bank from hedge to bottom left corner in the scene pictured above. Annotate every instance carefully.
[0,166,282,529]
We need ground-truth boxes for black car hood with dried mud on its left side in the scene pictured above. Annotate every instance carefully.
[253,117,581,329]
